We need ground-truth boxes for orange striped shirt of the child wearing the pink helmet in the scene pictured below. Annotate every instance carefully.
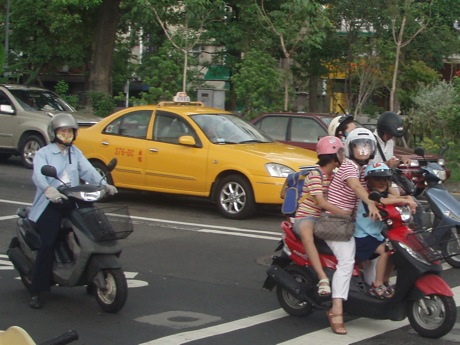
[295,168,332,218]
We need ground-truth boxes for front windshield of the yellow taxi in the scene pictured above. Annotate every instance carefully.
[191,114,273,144]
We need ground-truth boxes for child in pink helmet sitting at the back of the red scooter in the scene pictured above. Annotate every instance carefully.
[293,136,346,296]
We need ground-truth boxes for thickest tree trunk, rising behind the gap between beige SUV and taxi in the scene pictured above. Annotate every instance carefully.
[89,0,121,95]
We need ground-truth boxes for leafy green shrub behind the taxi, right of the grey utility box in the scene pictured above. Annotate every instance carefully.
[232,50,283,118]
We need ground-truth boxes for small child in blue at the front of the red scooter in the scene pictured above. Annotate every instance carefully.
[354,163,417,299]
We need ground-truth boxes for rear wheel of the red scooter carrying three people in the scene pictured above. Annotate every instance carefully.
[276,265,314,316]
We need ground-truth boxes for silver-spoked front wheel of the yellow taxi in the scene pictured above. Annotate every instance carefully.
[216,175,256,219]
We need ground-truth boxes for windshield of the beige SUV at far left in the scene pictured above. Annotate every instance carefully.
[9,89,75,112]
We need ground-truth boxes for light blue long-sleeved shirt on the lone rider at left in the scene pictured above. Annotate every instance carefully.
[29,143,107,222]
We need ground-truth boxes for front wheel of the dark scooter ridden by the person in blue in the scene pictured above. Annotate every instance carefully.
[94,268,128,313]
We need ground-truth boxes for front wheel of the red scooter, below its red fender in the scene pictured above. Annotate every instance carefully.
[407,295,457,339]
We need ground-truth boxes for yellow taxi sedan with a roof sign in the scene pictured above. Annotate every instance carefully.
[75,93,317,219]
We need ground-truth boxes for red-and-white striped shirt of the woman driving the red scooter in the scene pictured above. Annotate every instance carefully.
[327,159,366,212]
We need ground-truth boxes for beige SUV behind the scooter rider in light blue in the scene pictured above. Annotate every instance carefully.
[0,84,97,169]
